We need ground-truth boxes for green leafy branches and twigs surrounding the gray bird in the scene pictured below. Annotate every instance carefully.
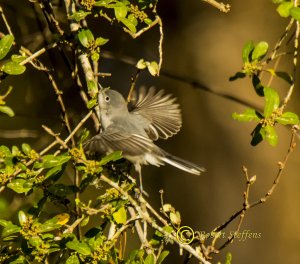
[0,0,300,264]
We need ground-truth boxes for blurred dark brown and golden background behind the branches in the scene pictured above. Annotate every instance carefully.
[0,0,300,264]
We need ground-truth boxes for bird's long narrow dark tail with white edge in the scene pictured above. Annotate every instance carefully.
[161,153,206,175]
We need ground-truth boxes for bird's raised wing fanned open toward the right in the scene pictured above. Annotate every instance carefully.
[131,87,182,140]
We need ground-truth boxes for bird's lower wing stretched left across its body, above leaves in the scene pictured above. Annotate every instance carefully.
[84,129,159,157]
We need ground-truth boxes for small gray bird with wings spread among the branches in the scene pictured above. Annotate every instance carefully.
[85,87,205,182]
